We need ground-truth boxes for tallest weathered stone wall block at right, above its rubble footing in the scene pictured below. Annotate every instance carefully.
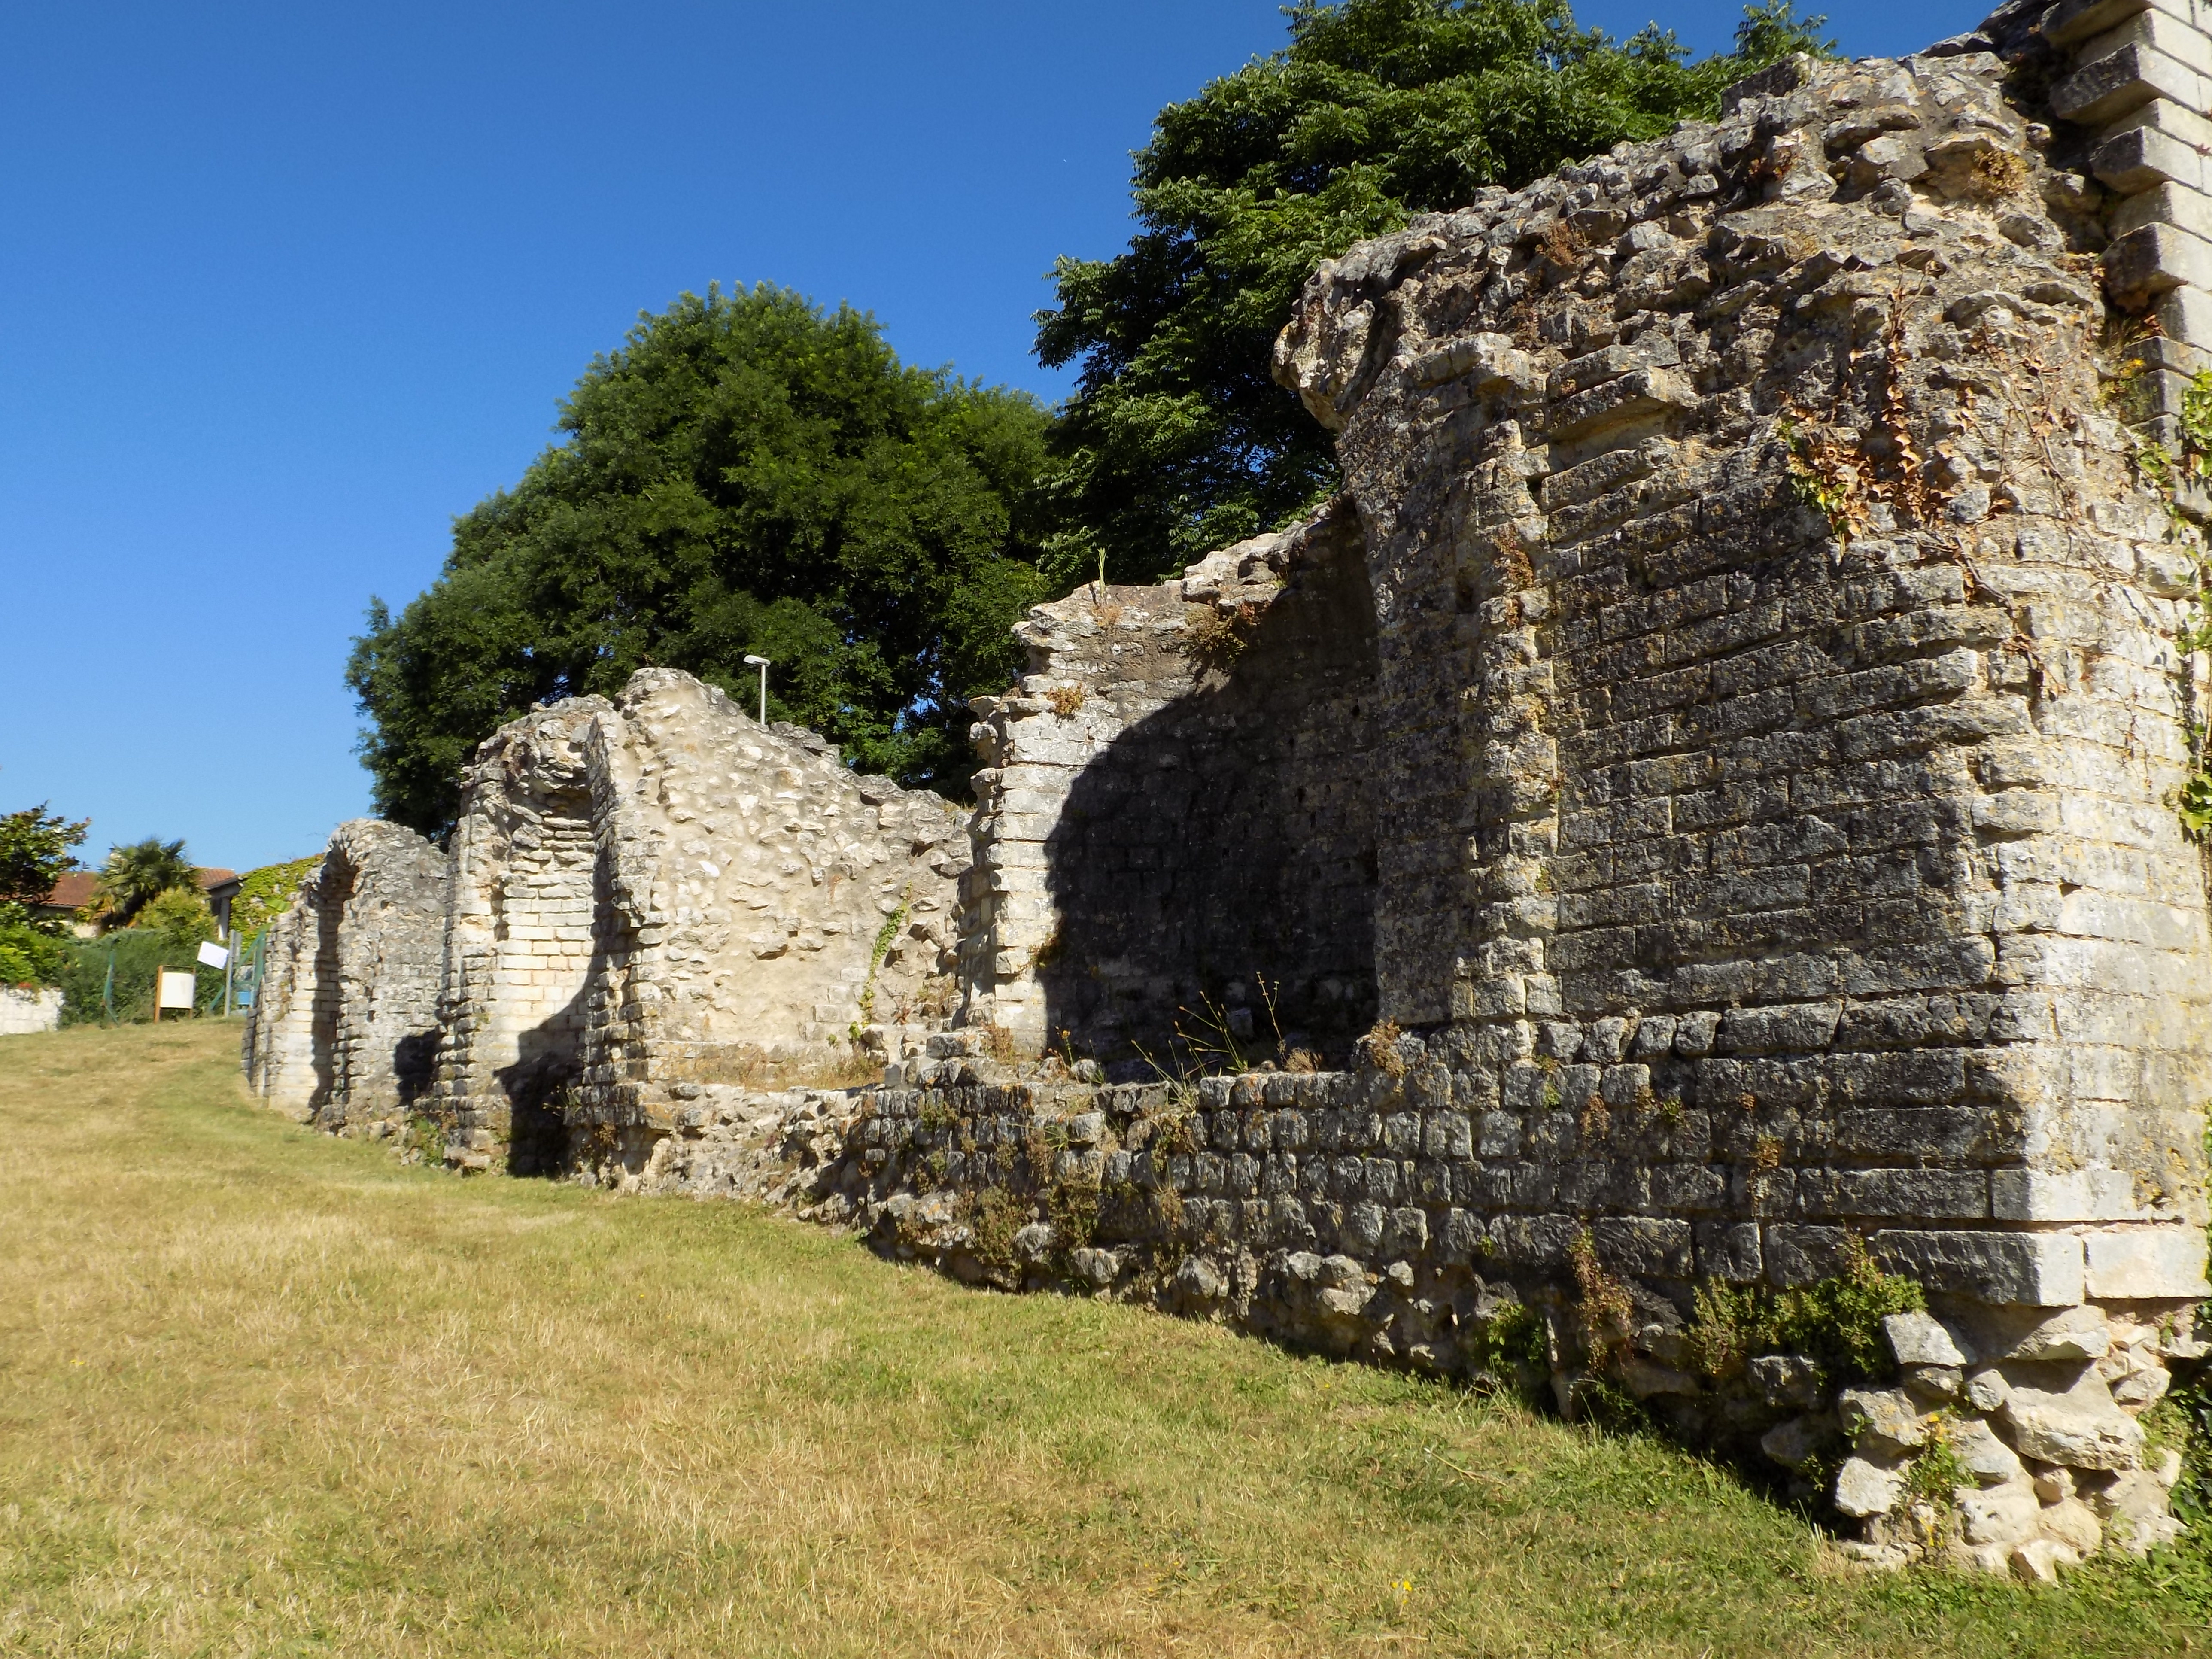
[1279,42,2212,1305]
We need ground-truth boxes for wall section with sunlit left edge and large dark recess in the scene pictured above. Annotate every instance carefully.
[962,504,1376,1075]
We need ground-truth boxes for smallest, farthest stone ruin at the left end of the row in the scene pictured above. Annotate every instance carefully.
[243,818,447,1130]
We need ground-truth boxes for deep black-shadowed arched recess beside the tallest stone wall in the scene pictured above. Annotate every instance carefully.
[1035,513,1378,1077]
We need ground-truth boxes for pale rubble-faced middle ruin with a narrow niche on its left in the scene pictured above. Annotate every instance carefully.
[438,668,969,1168]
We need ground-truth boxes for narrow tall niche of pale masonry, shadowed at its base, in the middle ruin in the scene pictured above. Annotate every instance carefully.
[491,787,599,1175]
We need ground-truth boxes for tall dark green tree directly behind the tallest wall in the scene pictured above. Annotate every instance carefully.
[1037,0,1834,588]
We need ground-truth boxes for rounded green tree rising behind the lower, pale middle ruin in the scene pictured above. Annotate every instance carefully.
[347,283,1046,836]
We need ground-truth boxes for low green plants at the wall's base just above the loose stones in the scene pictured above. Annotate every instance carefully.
[1688,1239,1926,1382]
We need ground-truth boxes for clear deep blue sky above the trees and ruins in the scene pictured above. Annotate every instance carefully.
[0,0,1984,869]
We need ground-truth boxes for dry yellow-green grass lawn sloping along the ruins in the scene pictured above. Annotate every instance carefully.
[0,1024,2212,1659]
